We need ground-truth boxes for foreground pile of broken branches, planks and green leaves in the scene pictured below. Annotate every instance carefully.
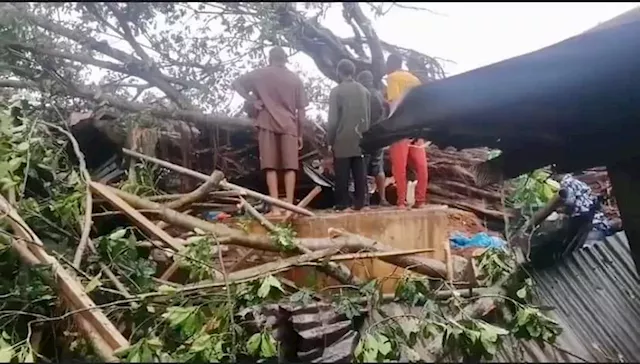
[0,101,560,362]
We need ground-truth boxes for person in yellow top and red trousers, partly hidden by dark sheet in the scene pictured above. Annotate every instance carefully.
[387,54,429,208]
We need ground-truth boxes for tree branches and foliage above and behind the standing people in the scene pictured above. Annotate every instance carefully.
[0,2,444,128]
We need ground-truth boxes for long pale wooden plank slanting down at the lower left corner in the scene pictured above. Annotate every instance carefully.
[0,196,129,360]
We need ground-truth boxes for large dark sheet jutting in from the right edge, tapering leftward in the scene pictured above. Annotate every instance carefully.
[362,9,640,182]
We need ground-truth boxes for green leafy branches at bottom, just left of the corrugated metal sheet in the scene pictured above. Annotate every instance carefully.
[354,250,562,362]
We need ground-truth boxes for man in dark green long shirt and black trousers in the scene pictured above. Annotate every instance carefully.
[327,59,371,210]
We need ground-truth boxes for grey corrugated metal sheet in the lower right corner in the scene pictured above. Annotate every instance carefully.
[496,233,640,362]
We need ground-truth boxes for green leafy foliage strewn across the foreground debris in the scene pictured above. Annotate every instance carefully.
[0,98,560,362]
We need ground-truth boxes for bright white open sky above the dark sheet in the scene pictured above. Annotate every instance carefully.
[296,2,638,75]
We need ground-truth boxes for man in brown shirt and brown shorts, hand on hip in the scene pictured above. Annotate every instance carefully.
[233,47,308,215]
